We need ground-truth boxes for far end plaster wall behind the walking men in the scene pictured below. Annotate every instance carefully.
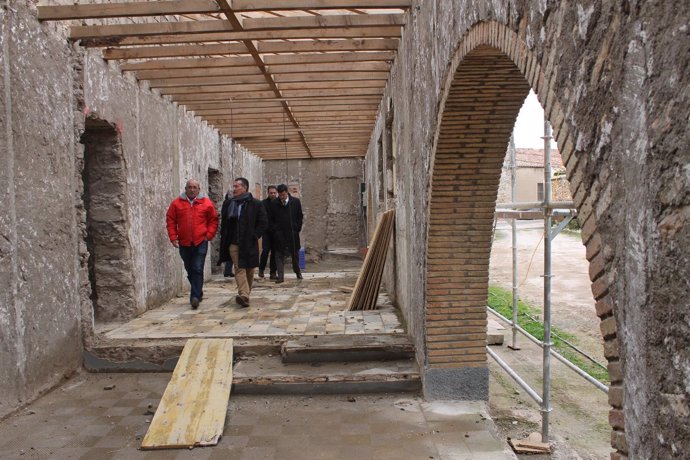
[263,159,363,259]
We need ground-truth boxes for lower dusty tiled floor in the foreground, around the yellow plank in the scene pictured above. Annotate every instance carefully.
[0,374,515,460]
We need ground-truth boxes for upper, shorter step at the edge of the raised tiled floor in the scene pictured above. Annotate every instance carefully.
[281,334,414,363]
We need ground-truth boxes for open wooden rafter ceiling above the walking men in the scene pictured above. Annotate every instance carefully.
[38,0,411,159]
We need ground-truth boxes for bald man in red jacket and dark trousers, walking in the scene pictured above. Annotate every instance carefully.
[165,179,218,309]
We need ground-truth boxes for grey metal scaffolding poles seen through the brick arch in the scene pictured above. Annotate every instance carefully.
[486,119,608,442]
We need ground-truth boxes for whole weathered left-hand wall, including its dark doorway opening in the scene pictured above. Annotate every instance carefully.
[0,1,263,417]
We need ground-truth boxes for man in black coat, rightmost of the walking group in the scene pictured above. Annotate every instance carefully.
[270,184,304,283]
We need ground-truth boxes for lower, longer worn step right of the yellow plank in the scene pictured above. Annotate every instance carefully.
[233,355,421,394]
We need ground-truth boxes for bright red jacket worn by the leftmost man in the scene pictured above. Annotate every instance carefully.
[165,192,218,246]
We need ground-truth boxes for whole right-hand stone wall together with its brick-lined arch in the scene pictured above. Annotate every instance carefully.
[365,0,690,458]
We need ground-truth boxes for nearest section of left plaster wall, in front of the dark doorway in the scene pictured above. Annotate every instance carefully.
[0,3,81,416]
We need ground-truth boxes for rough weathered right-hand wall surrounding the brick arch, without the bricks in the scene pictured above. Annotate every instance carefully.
[366,0,690,458]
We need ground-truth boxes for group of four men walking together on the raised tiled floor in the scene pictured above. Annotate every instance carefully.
[166,177,304,309]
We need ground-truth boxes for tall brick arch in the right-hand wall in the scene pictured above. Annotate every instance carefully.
[423,22,627,454]
